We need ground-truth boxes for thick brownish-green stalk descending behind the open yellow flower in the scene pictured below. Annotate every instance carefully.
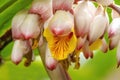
[39,42,71,80]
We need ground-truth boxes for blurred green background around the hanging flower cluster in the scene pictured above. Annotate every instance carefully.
[0,0,120,80]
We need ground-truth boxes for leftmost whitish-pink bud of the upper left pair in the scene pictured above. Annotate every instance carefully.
[12,11,27,39]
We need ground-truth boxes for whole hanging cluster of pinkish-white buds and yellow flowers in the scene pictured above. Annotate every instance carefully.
[11,0,120,70]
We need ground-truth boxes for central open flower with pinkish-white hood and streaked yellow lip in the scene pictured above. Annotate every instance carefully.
[44,11,77,60]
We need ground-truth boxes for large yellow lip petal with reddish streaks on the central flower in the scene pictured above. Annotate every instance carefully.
[44,28,77,60]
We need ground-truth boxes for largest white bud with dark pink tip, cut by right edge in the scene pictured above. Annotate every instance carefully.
[108,18,120,49]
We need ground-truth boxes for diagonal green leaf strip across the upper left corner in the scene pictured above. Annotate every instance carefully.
[0,0,32,29]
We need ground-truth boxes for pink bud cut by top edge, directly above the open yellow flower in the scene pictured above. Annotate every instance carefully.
[52,0,74,13]
